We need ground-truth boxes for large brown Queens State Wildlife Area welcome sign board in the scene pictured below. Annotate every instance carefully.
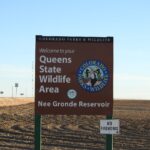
[35,36,113,115]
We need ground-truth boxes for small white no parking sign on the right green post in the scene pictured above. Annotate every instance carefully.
[100,119,120,134]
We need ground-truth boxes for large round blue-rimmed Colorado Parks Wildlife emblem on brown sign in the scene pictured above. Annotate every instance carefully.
[77,60,109,92]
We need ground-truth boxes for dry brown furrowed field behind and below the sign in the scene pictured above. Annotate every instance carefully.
[0,98,150,150]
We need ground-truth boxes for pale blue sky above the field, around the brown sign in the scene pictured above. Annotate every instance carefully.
[0,0,150,100]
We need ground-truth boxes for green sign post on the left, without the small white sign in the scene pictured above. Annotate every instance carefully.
[35,114,41,150]
